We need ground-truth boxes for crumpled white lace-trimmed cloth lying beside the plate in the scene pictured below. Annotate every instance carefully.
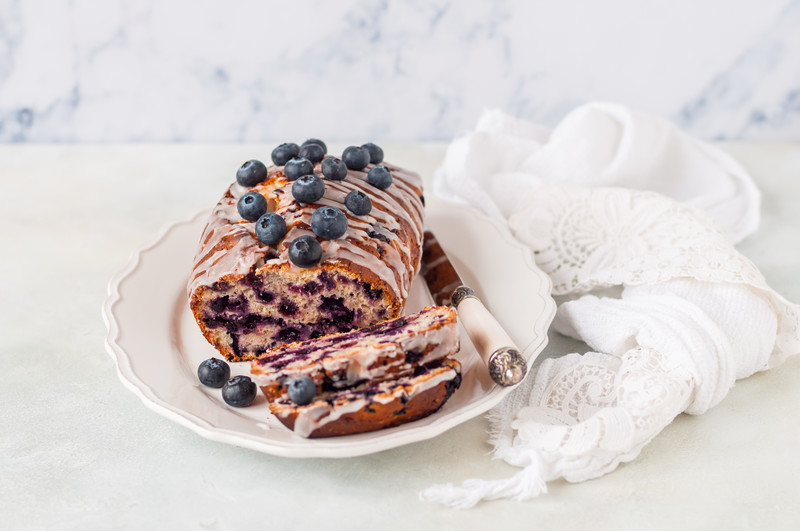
[421,104,800,508]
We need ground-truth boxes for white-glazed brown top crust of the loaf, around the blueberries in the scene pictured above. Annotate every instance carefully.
[187,157,423,301]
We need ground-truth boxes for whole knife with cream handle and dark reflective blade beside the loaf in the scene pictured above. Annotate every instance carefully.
[420,229,528,387]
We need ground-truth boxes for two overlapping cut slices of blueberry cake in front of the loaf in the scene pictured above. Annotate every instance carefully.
[251,306,461,437]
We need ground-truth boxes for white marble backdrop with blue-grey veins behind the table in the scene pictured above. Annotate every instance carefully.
[0,0,800,142]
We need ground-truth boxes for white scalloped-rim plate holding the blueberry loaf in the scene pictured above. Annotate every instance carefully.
[103,197,555,457]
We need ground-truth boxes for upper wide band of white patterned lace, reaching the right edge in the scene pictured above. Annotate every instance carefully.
[509,186,800,360]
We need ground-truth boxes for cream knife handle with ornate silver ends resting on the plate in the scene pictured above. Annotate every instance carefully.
[451,285,528,387]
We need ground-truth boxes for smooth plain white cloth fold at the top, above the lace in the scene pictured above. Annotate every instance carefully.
[434,103,760,243]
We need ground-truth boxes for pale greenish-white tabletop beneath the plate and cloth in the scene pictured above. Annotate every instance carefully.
[0,143,800,531]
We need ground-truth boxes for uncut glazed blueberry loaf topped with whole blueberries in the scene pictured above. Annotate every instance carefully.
[188,139,423,361]
